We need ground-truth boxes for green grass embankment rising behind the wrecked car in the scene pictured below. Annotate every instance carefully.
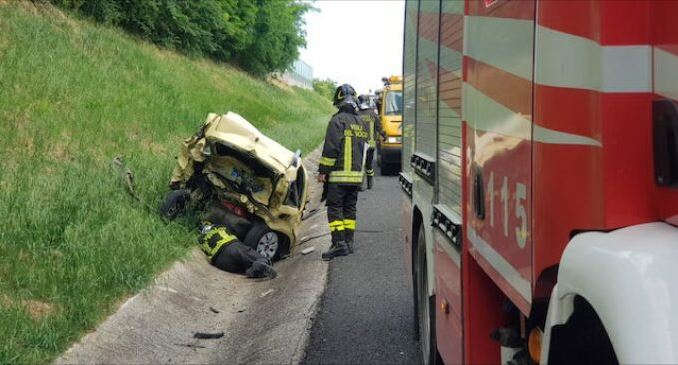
[0,2,331,363]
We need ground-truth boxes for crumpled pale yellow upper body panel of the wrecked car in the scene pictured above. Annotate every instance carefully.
[205,112,297,177]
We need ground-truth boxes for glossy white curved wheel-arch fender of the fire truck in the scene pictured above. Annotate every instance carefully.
[541,223,678,364]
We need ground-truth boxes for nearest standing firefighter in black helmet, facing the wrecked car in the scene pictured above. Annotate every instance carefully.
[318,84,368,260]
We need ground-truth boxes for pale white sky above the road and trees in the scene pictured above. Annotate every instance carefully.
[300,0,405,94]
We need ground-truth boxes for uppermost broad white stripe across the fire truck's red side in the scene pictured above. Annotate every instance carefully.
[464,16,652,93]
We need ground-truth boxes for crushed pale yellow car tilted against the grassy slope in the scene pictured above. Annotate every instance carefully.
[161,112,308,260]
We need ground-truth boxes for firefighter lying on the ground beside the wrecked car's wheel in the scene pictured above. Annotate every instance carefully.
[198,222,277,279]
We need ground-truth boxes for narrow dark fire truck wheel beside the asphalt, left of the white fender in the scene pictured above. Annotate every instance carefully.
[415,229,437,365]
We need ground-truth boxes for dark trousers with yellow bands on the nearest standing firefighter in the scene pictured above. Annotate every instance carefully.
[326,183,359,244]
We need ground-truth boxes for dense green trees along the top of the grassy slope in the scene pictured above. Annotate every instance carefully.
[47,0,311,76]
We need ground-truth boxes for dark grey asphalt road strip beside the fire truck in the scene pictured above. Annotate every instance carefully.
[302,172,420,364]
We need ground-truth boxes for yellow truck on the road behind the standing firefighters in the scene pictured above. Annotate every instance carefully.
[377,76,403,175]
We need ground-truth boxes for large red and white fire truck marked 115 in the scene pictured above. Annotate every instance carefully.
[400,0,678,364]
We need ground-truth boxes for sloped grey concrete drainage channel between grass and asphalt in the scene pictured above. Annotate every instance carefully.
[55,150,330,364]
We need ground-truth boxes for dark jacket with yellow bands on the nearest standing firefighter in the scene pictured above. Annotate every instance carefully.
[318,108,368,185]
